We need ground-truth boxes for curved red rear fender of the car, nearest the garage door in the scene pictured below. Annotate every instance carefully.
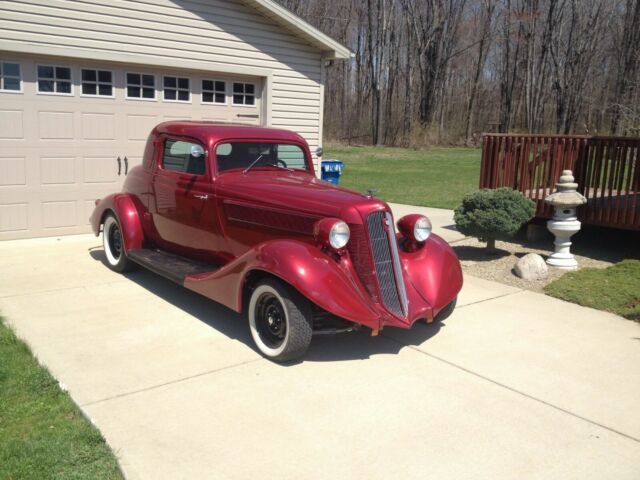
[89,193,144,253]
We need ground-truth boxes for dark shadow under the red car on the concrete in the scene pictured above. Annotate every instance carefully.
[89,247,443,366]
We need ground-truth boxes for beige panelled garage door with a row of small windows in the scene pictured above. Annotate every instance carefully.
[0,54,262,240]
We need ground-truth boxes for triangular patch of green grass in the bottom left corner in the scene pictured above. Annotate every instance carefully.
[0,318,123,480]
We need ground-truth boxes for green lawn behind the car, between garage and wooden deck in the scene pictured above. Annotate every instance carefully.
[323,145,481,209]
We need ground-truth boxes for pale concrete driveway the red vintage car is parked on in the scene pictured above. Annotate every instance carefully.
[0,218,640,480]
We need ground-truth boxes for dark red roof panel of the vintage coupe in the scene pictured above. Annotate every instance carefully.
[154,120,305,145]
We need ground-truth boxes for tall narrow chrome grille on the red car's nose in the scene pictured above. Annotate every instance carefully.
[367,212,408,317]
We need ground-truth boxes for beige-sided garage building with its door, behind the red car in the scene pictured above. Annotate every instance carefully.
[0,0,350,240]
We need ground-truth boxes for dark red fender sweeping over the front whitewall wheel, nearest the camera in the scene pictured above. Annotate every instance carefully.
[184,240,380,329]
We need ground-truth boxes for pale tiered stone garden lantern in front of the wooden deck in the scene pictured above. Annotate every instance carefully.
[544,170,587,270]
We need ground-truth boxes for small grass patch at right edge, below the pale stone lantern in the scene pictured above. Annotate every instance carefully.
[545,260,640,321]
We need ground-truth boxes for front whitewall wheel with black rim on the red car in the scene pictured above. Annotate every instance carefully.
[247,279,313,362]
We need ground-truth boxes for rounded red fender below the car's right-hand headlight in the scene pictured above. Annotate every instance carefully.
[400,234,462,316]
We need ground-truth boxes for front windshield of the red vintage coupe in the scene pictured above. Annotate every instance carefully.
[216,142,308,172]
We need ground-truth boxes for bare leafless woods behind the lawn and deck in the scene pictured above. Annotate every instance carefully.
[279,0,640,145]
